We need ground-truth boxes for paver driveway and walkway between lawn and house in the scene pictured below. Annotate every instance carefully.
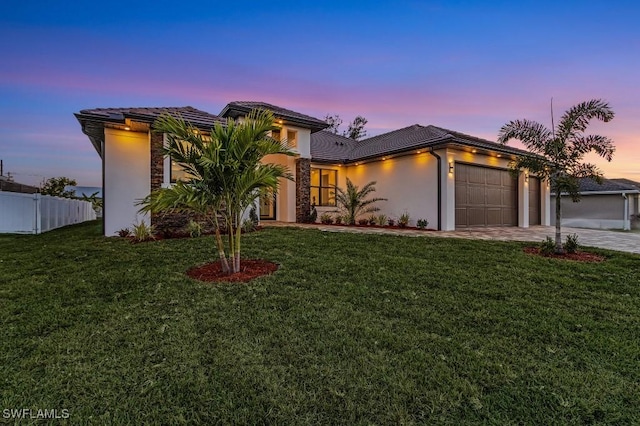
[262,222,640,254]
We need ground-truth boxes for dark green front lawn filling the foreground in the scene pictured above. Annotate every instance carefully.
[0,222,640,425]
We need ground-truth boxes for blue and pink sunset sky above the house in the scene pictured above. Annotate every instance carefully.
[0,0,640,186]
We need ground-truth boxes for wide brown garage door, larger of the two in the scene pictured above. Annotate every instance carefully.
[455,163,518,228]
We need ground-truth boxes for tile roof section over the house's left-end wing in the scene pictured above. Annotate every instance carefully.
[76,106,226,128]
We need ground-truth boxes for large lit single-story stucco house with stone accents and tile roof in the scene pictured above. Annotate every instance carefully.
[75,102,550,235]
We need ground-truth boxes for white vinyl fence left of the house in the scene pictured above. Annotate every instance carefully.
[0,191,96,234]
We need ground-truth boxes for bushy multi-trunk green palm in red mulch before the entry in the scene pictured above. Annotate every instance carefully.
[140,110,293,273]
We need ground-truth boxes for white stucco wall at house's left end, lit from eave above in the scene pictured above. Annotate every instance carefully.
[104,128,151,236]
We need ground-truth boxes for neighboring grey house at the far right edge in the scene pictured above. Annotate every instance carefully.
[551,179,640,230]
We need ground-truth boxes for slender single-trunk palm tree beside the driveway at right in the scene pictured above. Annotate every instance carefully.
[498,99,615,253]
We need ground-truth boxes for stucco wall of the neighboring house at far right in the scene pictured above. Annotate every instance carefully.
[551,194,632,229]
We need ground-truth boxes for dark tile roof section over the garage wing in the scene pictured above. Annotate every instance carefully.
[311,124,531,162]
